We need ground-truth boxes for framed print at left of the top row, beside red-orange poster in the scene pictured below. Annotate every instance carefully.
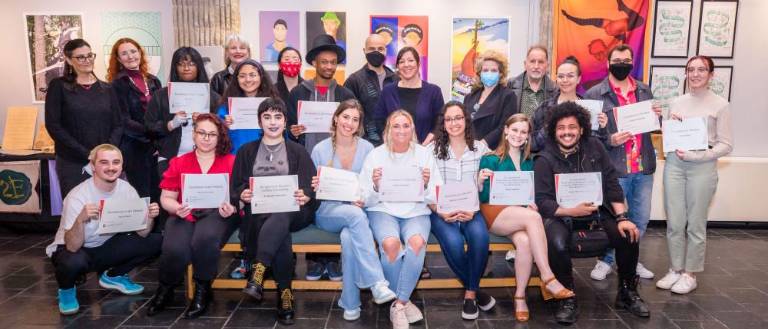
[652,0,693,58]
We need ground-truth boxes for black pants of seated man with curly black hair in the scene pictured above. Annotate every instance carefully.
[544,212,640,289]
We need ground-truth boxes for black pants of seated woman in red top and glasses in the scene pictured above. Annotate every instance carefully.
[159,209,228,285]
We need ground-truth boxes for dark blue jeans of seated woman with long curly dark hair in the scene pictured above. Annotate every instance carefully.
[429,211,488,291]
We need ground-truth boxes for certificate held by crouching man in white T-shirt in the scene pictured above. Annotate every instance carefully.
[96,198,149,234]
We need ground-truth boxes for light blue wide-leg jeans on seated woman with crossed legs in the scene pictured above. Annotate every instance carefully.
[315,201,385,310]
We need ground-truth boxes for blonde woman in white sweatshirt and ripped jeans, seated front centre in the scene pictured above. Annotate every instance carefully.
[360,110,442,328]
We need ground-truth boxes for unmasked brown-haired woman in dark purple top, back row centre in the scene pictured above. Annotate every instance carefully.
[373,47,445,145]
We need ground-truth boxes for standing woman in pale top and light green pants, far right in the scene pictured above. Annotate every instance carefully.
[656,56,733,294]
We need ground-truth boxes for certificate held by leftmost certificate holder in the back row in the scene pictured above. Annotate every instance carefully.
[168,81,211,115]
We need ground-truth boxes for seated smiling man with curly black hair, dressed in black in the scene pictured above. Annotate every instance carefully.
[534,102,650,324]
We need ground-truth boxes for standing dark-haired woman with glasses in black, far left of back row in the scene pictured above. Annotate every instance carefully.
[45,39,123,196]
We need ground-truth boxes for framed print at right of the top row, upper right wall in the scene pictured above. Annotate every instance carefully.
[698,0,739,58]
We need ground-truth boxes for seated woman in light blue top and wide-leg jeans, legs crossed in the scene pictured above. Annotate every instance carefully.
[312,99,396,321]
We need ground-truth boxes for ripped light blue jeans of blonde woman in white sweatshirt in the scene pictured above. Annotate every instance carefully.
[368,211,430,301]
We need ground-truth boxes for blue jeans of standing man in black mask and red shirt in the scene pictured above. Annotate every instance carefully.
[603,173,653,264]
